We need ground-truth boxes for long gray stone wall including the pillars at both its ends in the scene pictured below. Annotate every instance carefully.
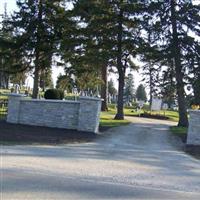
[7,94,101,133]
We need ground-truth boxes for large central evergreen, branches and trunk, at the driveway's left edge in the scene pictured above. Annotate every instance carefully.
[63,0,144,119]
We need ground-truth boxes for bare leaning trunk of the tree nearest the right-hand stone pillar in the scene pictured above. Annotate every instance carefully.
[171,0,188,127]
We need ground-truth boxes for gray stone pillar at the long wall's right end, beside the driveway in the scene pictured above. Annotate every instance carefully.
[78,97,102,133]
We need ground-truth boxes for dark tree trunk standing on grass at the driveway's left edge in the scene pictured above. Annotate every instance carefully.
[115,10,125,119]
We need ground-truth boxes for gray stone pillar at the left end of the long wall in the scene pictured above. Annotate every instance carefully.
[7,94,24,124]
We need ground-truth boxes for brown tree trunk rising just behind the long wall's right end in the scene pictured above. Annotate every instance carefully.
[101,65,108,111]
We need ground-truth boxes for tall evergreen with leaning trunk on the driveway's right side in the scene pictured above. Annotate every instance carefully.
[141,0,200,126]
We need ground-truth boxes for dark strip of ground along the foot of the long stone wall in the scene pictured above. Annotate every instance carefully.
[0,120,99,145]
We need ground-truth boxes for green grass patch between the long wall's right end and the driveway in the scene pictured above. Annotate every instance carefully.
[100,111,130,127]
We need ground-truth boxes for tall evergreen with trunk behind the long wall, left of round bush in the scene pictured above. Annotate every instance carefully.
[11,0,64,98]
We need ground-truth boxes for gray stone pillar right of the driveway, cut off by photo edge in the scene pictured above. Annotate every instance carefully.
[187,110,200,146]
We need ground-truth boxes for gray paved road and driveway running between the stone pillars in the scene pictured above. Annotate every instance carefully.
[1,118,200,200]
